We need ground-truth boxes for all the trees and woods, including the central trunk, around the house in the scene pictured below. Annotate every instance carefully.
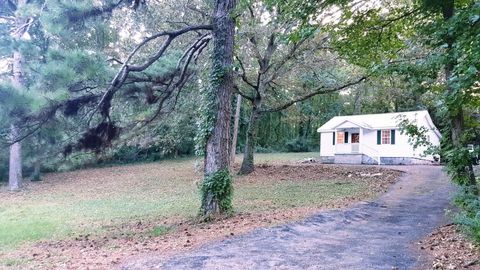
[0,0,480,230]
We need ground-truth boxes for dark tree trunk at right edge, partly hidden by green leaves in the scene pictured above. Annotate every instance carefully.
[442,0,479,192]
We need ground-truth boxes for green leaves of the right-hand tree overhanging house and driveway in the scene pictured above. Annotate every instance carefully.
[318,0,480,243]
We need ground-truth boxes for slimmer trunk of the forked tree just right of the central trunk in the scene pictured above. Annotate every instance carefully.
[239,96,262,174]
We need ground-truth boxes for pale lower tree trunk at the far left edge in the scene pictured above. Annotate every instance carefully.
[8,124,23,190]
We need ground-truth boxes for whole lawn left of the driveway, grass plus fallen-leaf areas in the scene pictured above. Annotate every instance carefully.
[0,153,400,269]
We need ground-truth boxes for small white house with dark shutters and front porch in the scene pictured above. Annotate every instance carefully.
[317,111,441,164]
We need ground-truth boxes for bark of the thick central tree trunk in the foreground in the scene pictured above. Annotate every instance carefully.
[202,0,236,216]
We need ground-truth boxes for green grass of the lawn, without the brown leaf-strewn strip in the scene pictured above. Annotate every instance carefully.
[0,153,367,253]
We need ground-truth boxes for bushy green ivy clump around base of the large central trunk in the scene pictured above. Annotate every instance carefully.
[200,169,233,213]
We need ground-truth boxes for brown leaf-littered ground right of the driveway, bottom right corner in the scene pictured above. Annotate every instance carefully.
[419,224,480,270]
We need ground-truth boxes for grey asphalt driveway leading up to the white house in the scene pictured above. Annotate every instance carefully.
[125,166,453,270]
